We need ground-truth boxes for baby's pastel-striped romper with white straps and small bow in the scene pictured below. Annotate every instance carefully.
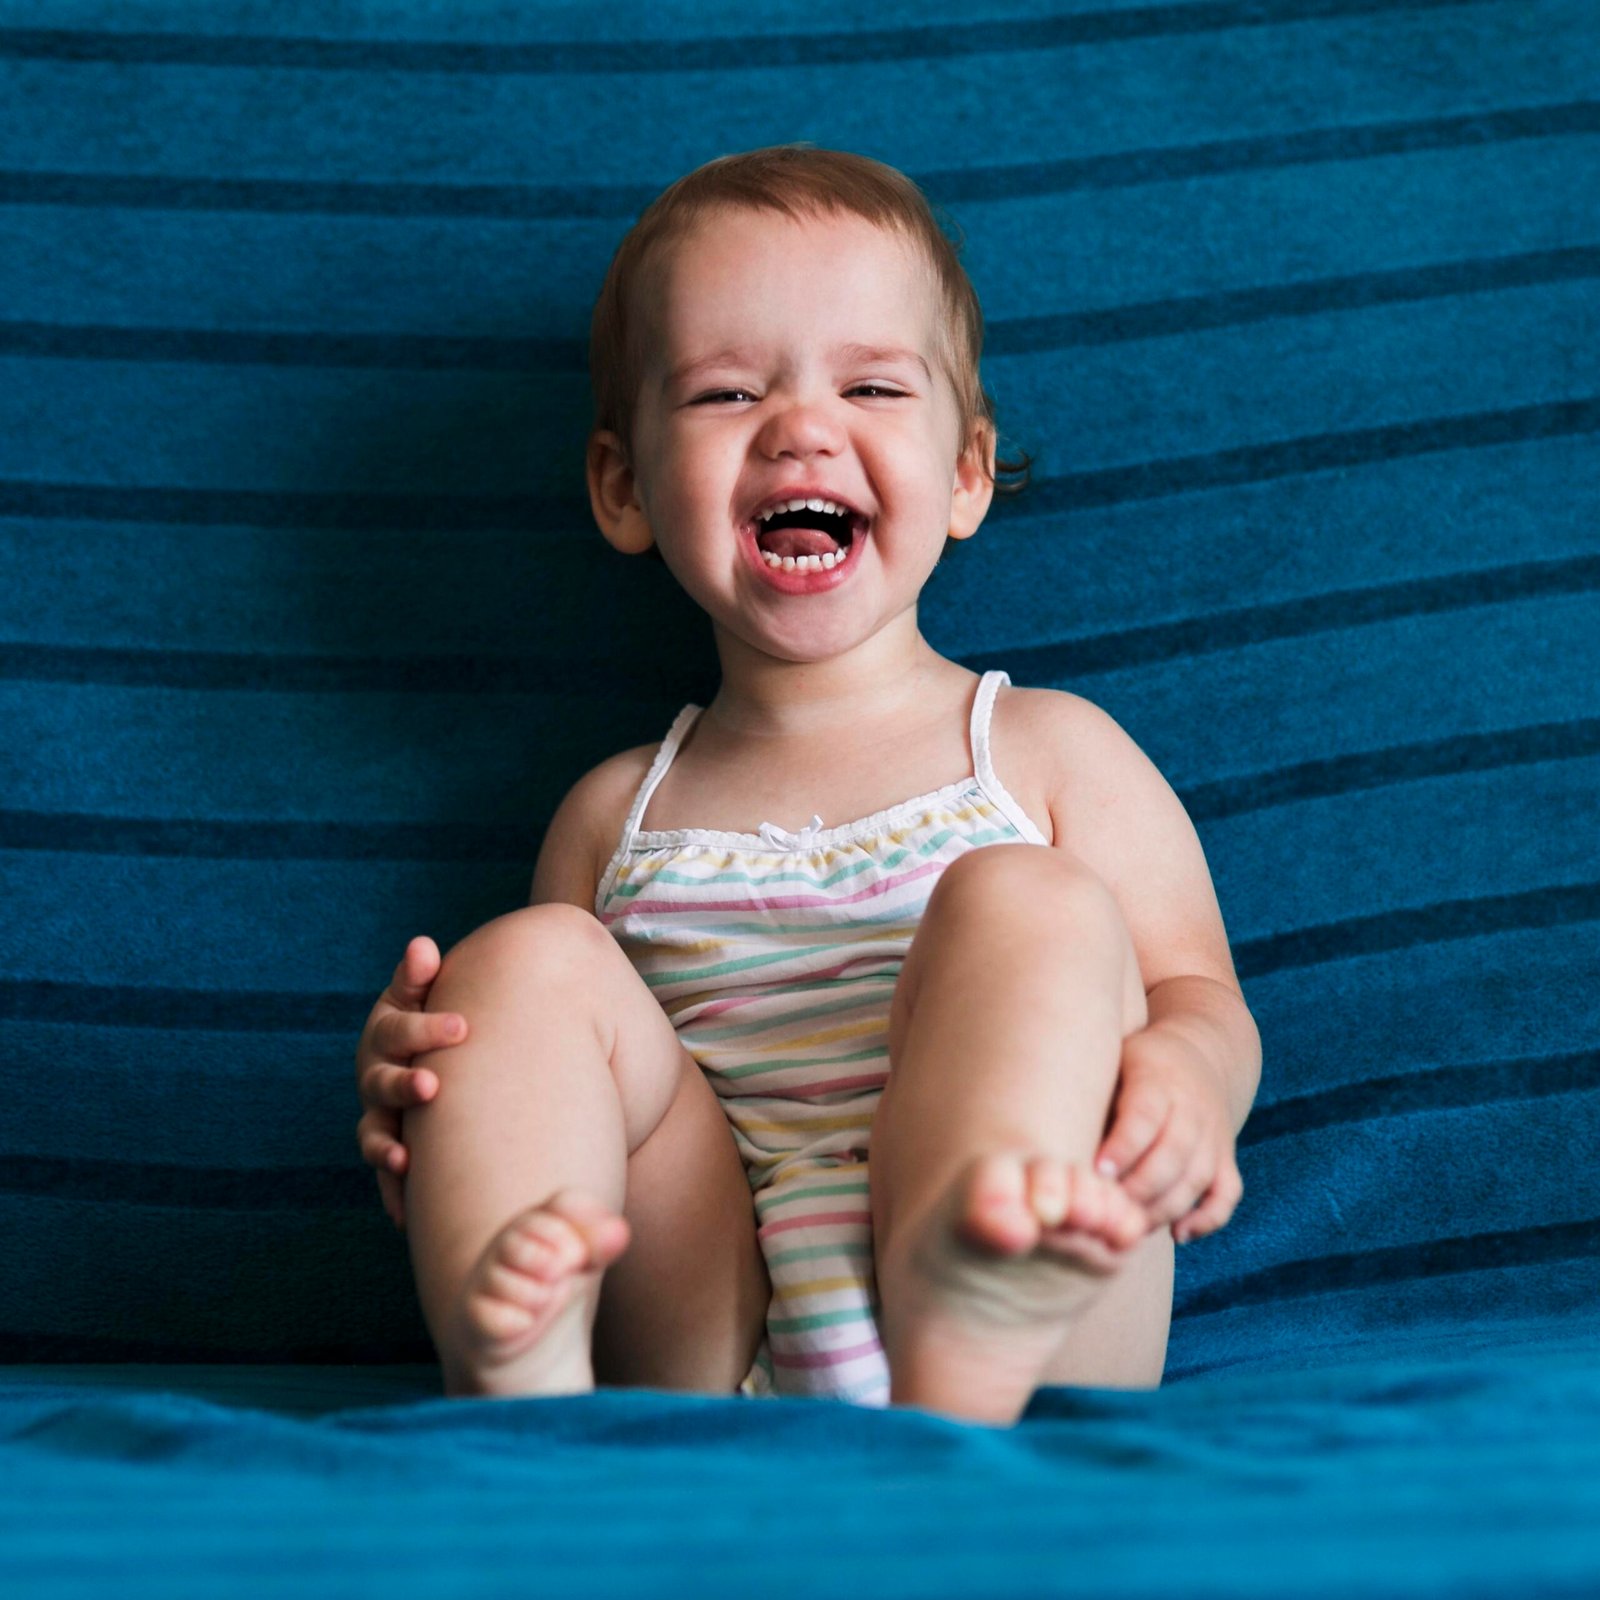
[595,672,1048,1406]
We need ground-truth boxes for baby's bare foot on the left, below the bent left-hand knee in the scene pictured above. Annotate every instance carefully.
[446,1189,629,1395]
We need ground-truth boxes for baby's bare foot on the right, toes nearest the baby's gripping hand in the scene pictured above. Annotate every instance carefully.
[878,1152,1150,1422]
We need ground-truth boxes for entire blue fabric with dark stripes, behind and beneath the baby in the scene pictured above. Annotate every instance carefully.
[0,0,1600,1595]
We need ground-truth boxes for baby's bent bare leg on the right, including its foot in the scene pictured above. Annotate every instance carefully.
[870,845,1173,1424]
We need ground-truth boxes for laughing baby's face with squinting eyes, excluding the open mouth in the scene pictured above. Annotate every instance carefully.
[595,211,989,659]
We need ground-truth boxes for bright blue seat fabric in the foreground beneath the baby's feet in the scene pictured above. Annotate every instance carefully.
[0,1317,1600,1600]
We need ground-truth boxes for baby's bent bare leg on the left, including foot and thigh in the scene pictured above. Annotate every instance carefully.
[405,904,766,1395]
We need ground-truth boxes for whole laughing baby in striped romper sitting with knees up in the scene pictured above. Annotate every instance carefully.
[357,144,1261,1426]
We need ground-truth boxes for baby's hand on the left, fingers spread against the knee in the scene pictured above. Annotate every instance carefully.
[355,933,467,1232]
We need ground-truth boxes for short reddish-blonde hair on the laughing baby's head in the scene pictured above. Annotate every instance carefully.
[589,141,1030,493]
